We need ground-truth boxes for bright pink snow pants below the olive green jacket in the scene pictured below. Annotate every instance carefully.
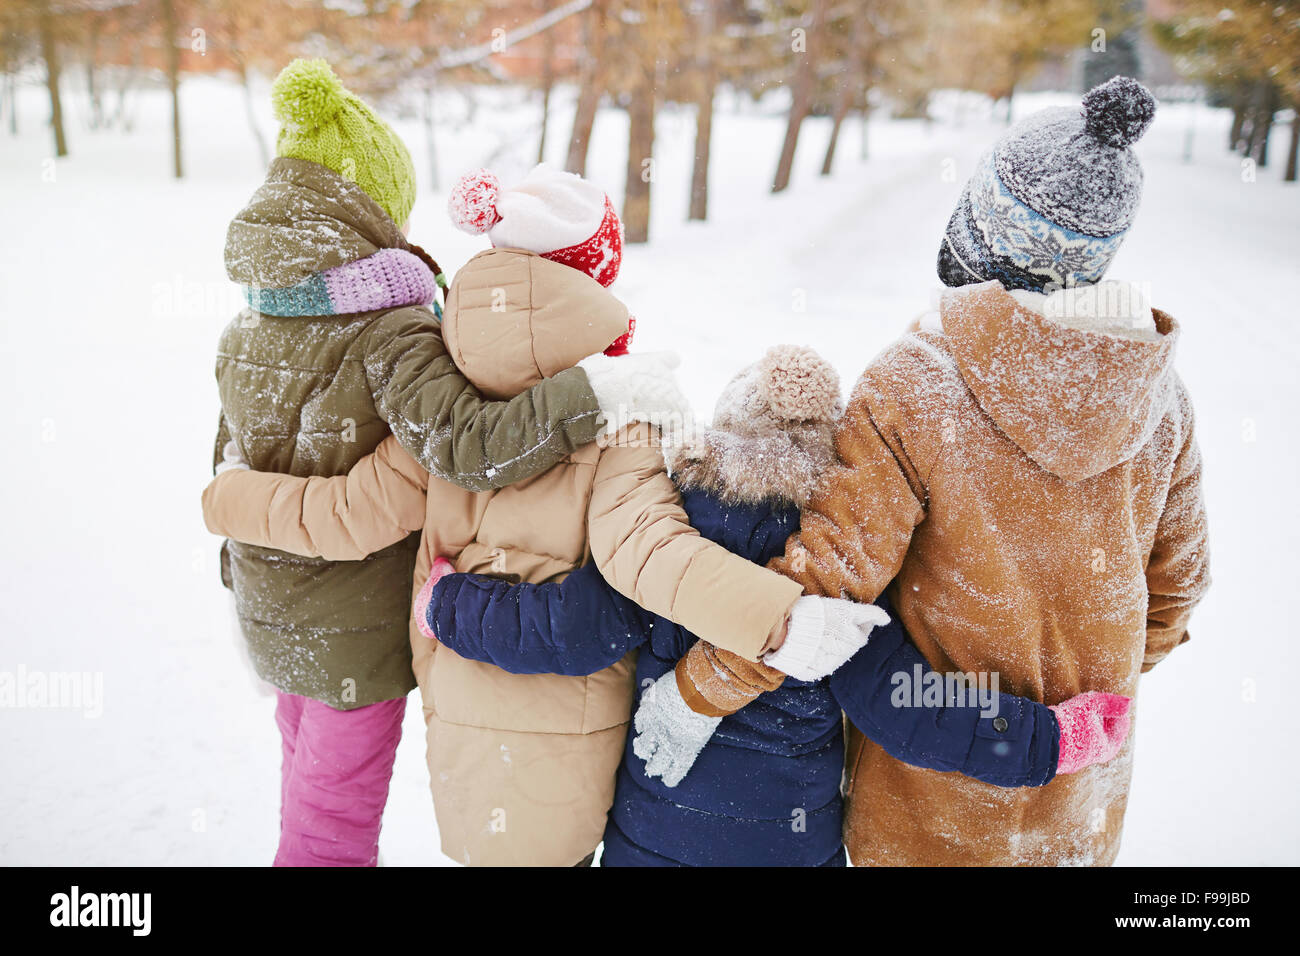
[274,691,406,866]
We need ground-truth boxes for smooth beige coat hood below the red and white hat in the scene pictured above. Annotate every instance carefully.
[442,248,628,399]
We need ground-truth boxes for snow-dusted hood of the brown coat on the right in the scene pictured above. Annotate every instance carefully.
[940,281,1178,483]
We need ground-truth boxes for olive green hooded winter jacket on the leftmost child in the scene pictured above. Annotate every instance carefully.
[215,159,599,710]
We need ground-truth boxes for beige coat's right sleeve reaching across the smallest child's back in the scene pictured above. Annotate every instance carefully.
[588,425,802,661]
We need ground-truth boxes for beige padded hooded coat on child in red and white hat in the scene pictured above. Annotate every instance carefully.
[204,250,800,866]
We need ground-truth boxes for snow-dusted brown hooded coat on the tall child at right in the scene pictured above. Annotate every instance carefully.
[772,282,1209,865]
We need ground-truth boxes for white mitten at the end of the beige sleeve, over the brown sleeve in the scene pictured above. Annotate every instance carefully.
[763,597,889,680]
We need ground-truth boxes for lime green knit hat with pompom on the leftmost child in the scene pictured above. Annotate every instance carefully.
[270,60,415,226]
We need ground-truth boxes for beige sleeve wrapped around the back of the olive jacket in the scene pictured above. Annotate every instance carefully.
[203,436,429,561]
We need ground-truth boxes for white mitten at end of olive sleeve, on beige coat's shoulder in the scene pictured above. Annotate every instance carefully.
[577,352,694,434]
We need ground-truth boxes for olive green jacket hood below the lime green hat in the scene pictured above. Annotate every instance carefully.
[226,157,411,289]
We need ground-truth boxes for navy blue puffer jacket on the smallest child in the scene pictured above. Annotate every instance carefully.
[428,490,1058,866]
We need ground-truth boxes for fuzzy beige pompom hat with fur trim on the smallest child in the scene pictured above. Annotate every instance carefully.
[664,345,844,507]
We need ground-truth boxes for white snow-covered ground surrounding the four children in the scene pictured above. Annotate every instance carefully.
[0,81,1300,865]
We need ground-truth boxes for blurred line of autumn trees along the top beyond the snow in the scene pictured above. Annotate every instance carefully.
[0,0,1300,227]
